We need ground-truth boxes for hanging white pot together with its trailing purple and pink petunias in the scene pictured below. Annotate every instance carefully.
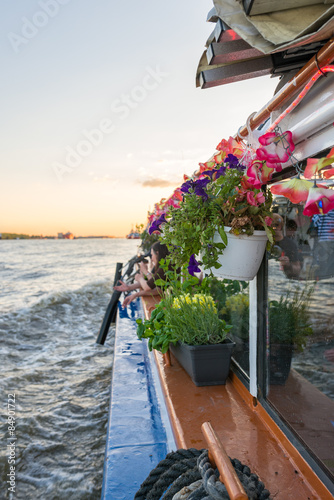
[161,148,273,280]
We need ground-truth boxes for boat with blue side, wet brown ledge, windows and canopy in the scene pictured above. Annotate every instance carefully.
[102,0,334,500]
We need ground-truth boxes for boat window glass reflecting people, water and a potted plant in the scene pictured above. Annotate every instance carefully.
[267,200,334,480]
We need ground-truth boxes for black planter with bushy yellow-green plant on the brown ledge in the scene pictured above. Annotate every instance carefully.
[137,270,235,386]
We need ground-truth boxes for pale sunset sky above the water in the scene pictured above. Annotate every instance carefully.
[0,0,278,237]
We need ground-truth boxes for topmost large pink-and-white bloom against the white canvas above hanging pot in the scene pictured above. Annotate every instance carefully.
[256,130,295,166]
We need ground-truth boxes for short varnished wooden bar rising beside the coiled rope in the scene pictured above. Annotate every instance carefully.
[201,422,248,500]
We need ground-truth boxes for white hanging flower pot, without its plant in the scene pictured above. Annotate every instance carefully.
[211,227,268,281]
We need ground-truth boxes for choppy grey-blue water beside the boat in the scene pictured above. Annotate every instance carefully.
[0,239,138,500]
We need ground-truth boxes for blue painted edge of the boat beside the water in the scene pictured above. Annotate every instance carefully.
[101,300,176,500]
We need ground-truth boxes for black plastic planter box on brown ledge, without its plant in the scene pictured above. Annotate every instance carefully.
[170,339,235,386]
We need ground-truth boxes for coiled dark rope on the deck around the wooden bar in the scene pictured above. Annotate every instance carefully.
[134,448,270,500]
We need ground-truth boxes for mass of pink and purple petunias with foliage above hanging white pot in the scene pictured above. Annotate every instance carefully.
[145,132,294,274]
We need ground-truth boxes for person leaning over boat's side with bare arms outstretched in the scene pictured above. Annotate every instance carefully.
[114,241,169,307]
